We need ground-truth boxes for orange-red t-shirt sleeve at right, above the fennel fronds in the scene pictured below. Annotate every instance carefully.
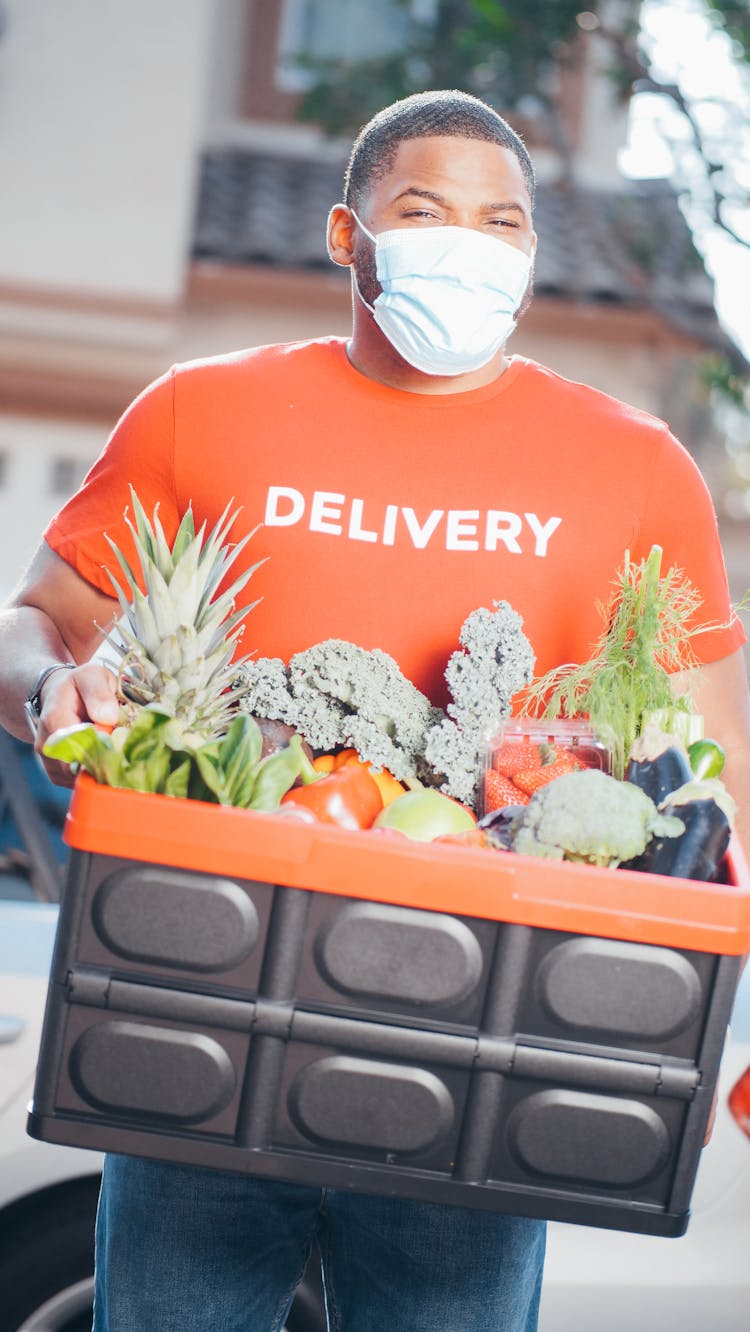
[641,428,746,663]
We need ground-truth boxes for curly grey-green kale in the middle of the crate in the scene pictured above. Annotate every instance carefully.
[240,602,534,806]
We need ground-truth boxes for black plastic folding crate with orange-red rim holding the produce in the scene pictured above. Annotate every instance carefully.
[29,778,750,1235]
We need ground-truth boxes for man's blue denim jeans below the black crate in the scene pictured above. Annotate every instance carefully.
[93,1156,545,1332]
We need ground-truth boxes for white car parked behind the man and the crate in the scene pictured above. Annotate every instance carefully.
[0,737,750,1332]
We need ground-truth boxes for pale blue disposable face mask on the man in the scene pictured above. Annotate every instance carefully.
[352,209,532,374]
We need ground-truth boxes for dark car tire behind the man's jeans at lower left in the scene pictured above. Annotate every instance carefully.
[0,1176,326,1332]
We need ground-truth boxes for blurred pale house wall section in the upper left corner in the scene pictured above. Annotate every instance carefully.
[0,0,215,302]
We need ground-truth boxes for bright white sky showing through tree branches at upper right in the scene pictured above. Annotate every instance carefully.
[619,0,750,358]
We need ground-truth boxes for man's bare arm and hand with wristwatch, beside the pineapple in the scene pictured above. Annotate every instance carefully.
[0,545,119,783]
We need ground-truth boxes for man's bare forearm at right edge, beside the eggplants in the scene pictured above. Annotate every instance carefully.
[678,649,750,852]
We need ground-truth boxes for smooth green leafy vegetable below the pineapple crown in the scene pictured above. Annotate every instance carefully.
[44,707,309,811]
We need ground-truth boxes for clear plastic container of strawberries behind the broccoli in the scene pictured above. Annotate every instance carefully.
[480,717,611,814]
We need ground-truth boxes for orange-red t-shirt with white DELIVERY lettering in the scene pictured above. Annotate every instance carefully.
[45,338,745,703]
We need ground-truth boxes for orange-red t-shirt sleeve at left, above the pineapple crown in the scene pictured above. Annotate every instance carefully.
[44,368,181,597]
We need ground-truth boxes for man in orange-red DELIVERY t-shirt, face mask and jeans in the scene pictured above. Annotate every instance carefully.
[0,92,750,1332]
